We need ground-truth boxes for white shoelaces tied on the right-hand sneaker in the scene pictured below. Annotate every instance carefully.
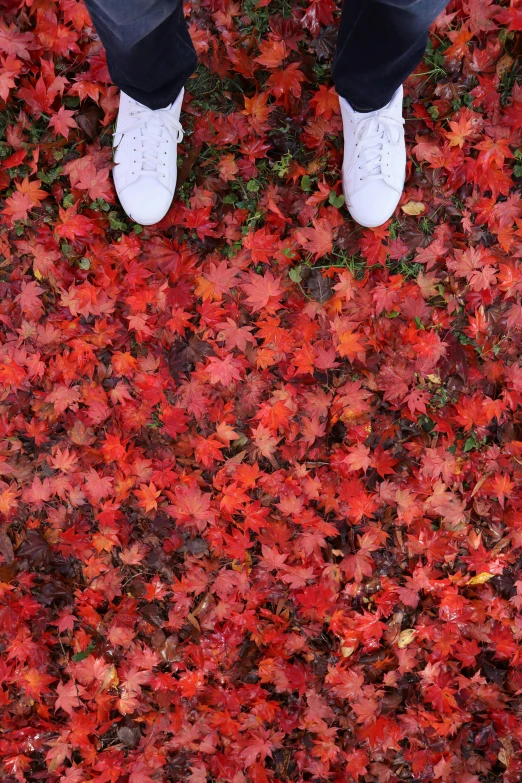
[352,114,404,181]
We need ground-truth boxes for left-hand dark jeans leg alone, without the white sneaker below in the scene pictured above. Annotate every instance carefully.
[85,0,197,109]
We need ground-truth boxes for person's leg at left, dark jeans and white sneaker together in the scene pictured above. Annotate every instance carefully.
[85,0,197,225]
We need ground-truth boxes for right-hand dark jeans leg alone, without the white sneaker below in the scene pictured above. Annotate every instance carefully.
[332,0,448,112]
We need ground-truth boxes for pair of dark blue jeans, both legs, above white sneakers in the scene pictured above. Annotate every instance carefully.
[85,0,447,111]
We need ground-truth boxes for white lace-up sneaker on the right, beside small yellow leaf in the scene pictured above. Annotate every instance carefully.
[339,86,406,228]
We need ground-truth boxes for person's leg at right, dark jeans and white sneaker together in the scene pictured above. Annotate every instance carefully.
[333,0,447,228]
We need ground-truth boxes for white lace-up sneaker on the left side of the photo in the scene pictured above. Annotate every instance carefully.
[113,90,184,226]
